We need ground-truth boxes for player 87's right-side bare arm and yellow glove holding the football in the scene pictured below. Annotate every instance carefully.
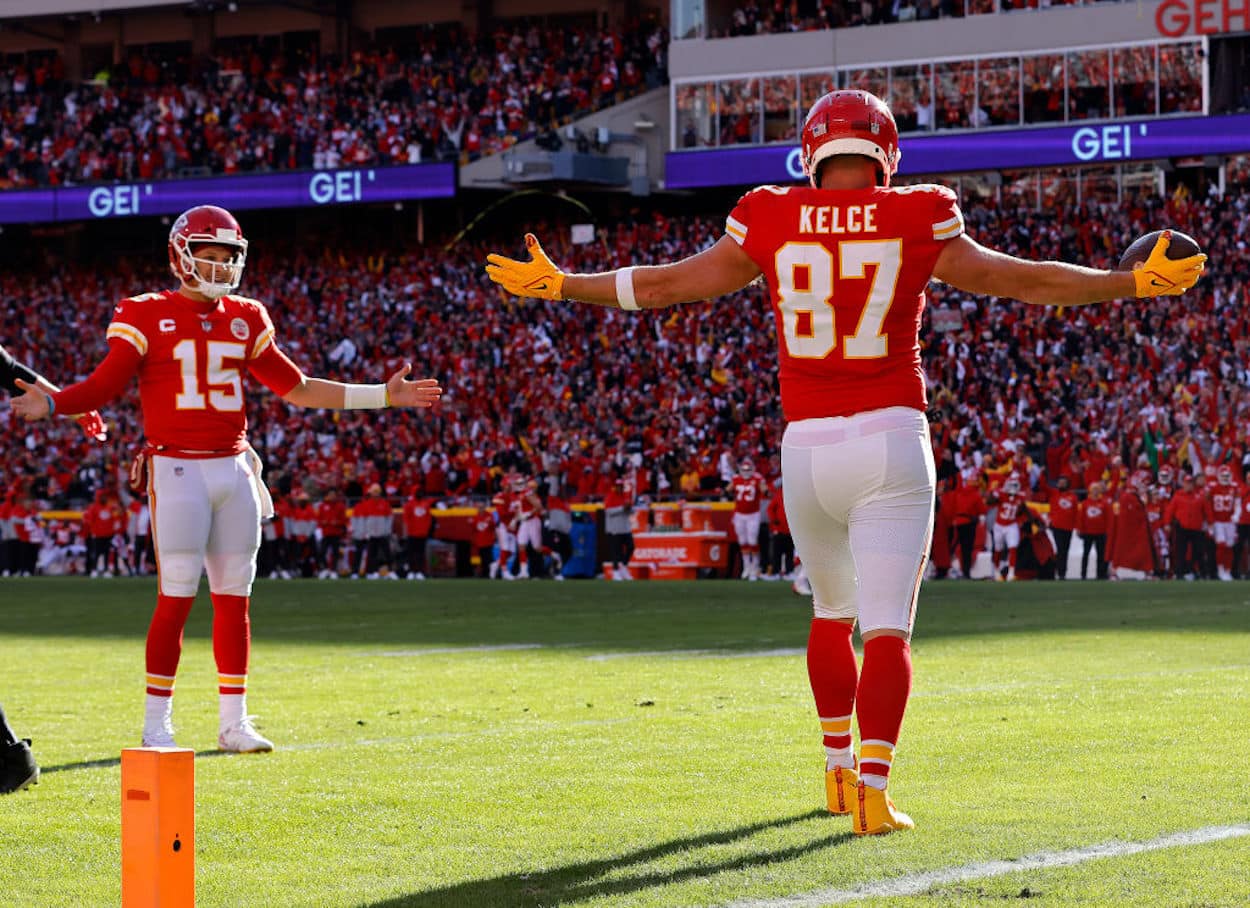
[934,234,1206,306]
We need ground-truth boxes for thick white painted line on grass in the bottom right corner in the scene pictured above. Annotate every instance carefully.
[725,823,1250,908]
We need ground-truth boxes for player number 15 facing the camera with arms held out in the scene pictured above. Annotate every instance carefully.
[14,205,441,752]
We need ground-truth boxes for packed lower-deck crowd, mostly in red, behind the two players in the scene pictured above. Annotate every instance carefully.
[0,160,1250,574]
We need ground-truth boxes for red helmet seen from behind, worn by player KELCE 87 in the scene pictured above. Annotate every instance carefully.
[803,91,903,186]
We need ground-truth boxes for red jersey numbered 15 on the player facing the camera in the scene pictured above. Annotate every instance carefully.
[108,290,283,454]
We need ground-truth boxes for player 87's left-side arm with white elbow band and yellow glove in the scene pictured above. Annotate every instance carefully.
[486,234,760,309]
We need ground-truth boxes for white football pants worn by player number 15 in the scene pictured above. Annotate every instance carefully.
[149,451,263,597]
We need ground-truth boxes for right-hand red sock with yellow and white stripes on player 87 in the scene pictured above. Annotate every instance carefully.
[855,637,911,788]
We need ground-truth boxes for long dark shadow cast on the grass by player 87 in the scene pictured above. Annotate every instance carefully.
[361,810,855,908]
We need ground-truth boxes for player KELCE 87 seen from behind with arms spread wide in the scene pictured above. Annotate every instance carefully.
[486,91,1206,834]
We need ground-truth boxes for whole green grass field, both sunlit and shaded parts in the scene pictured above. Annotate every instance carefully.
[0,579,1250,908]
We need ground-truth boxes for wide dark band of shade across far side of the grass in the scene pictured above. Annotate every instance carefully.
[0,578,1250,660]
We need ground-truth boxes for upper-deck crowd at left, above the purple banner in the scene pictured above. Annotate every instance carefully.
[0,18,668,189]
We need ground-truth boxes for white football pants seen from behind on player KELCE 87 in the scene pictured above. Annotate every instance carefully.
[781,406,936,633]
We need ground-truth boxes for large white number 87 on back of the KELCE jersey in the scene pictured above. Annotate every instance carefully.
[775,239,903,359]
